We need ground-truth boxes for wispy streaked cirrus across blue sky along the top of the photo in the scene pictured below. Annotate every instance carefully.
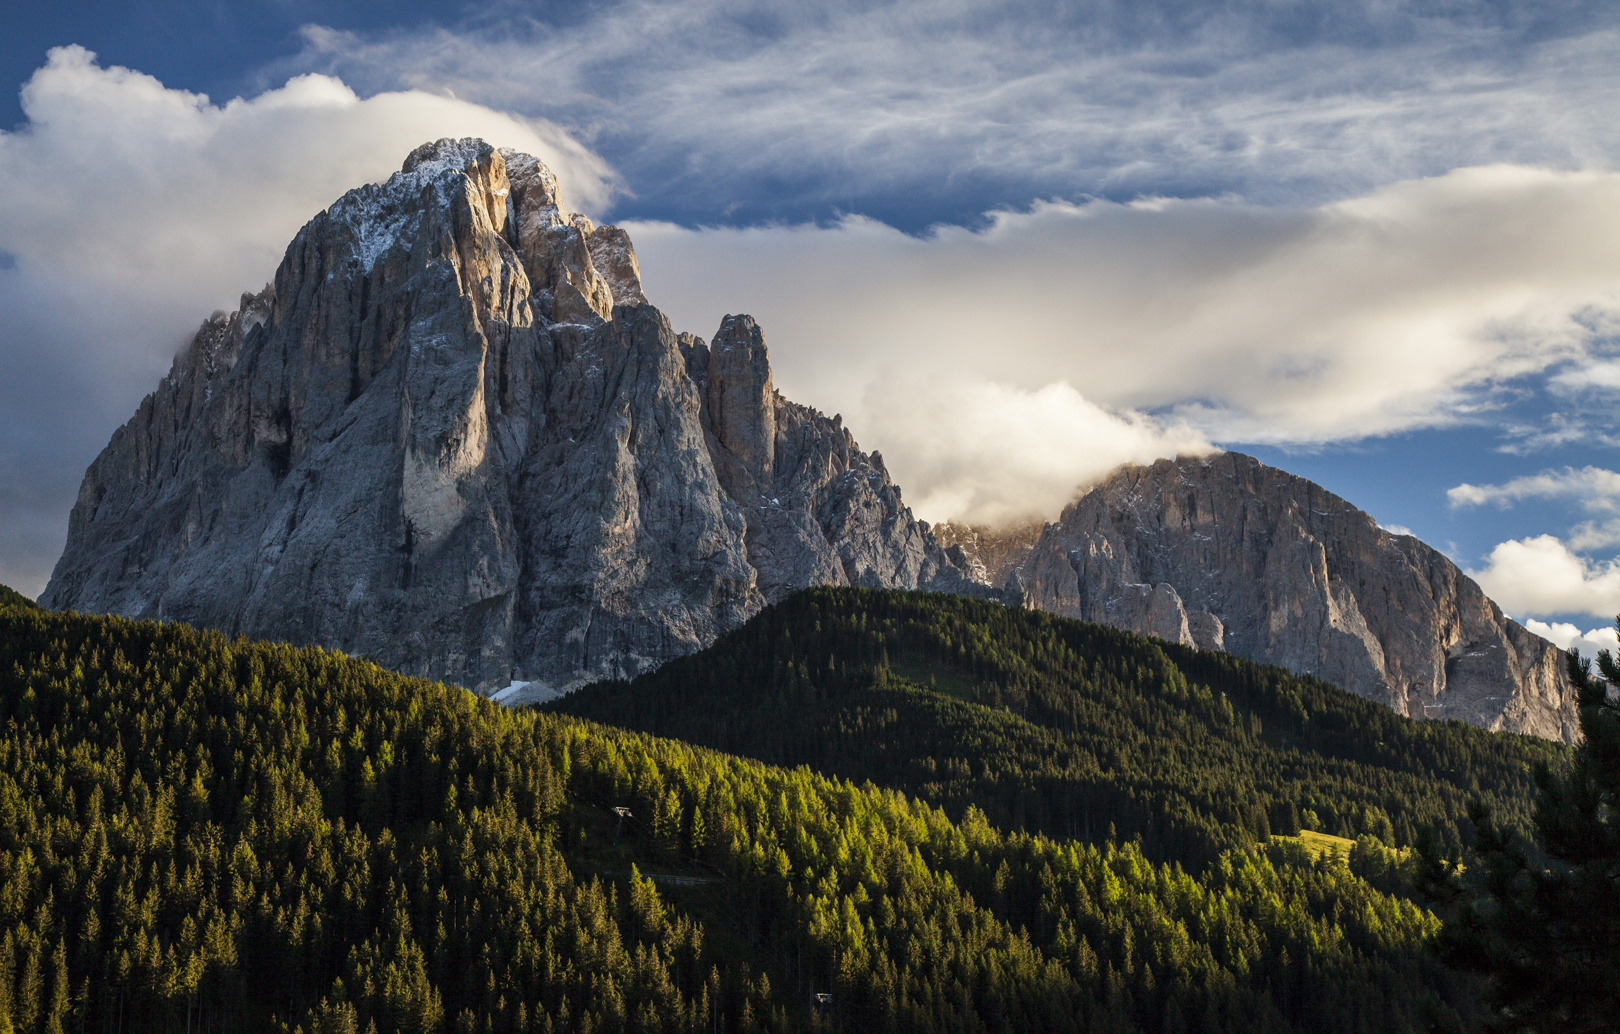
[279,0,1620,230]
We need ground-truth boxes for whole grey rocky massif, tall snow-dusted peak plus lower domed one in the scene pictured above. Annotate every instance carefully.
[41,139,1578,741]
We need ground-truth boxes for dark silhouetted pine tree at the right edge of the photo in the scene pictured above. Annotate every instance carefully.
[1442,650,1620,1034]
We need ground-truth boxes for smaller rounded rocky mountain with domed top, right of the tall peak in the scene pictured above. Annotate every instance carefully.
[1009,452,1580,742]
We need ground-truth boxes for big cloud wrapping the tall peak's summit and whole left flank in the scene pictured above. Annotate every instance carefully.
[0,47,614,595]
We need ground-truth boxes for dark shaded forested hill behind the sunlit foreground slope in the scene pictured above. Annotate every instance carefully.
[549,588,1568,865]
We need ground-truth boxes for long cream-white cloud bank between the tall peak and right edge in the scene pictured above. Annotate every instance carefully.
[625,165,1620,519]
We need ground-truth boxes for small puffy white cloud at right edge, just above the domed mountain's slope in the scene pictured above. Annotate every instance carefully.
[1468,535,1620,619]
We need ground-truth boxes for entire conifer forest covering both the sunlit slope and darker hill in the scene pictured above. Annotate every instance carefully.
[0,590,1570,1034]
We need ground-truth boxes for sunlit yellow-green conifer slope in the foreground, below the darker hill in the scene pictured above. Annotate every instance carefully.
[0,595,1473,1034]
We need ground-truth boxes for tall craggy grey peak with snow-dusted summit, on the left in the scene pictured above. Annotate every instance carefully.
[42,139,983,699]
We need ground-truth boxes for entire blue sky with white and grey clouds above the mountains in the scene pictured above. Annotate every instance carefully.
[0,0,1620,652]
